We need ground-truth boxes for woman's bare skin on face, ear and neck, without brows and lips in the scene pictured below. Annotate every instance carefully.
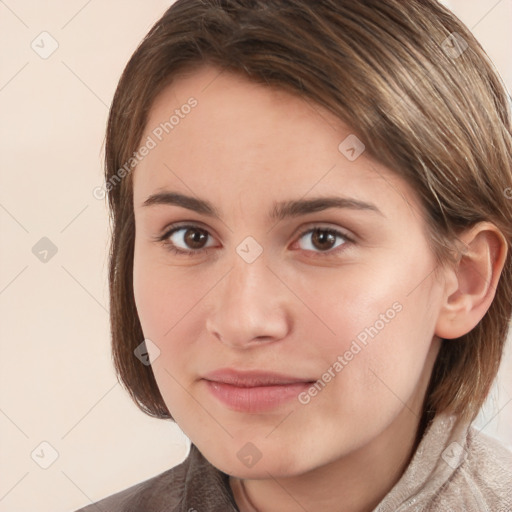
[133,66,504,512]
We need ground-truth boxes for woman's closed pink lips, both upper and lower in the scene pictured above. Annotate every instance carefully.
[203,368,315,413]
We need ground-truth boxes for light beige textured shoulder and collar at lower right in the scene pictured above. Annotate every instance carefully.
[373,413,512,512]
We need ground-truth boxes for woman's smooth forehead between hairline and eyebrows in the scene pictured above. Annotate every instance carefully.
[134,66,424,222]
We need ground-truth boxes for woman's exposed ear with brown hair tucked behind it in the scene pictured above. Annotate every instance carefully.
[435,222,508,339]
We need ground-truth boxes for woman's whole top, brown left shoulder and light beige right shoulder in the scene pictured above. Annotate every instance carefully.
[77,415,512,512]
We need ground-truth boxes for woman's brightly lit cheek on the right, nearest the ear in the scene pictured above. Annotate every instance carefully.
[300,244,441,406]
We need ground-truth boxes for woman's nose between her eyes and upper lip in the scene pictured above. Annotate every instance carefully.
[206,255,291,349]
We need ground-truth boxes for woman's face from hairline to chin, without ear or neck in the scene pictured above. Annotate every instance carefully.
[133,67,442,478]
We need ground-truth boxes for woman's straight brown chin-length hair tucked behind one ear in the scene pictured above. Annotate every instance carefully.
[105,0,512,420]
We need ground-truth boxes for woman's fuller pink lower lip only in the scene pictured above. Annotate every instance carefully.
[205,380,313,413]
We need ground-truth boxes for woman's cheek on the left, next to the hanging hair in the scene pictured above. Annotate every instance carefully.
[133,251,218,400]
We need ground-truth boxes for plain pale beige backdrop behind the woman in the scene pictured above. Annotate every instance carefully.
[0,0,512,512]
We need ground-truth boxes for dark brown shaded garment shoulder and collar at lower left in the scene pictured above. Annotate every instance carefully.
[72,444,238,512]
